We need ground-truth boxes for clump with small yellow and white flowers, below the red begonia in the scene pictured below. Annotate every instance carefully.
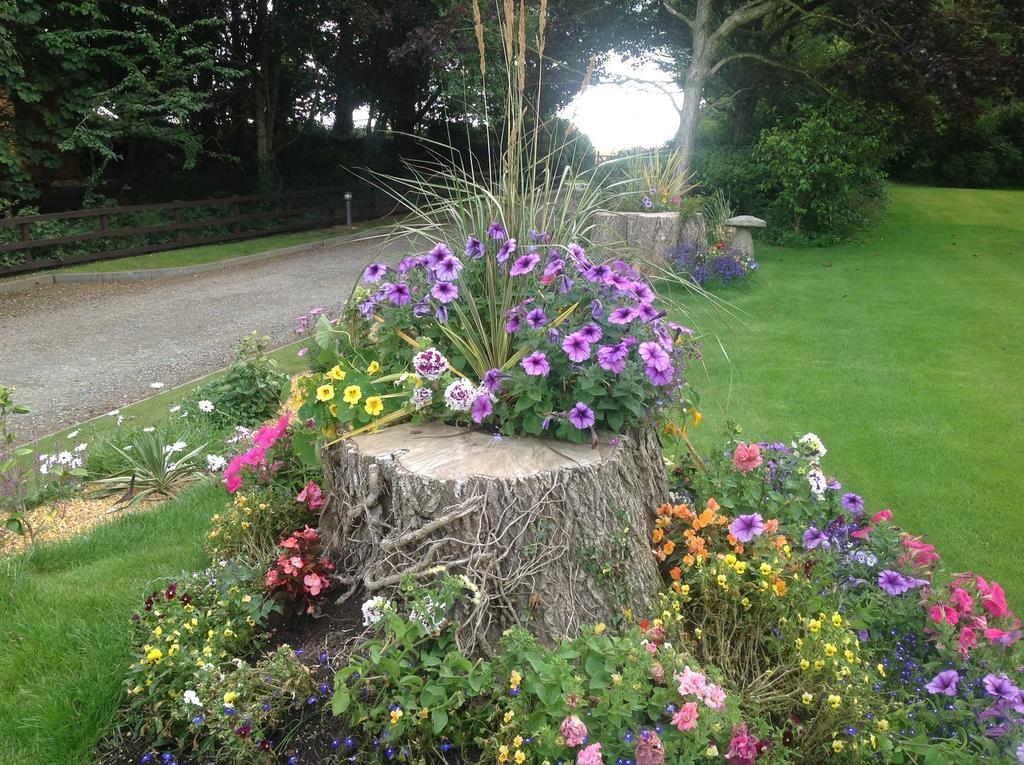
[125,561,311,762]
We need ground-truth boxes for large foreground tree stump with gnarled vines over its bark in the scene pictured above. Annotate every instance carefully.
[321,423,669,650]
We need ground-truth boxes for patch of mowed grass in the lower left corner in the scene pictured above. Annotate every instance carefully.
[0,482,224,765]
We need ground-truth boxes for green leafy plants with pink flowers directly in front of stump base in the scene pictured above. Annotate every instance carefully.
[334,575,738,765]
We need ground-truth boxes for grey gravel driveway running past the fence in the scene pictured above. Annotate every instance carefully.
[0,233,398,435]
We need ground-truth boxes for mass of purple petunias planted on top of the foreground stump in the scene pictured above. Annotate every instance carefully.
[319,233,692,441]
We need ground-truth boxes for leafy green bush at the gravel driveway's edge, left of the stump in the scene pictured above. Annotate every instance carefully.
[182,333,288,427]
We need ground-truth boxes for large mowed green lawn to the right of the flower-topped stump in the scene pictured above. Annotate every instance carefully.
[679,186,1024,609]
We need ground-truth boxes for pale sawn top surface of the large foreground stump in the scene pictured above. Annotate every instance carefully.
[352,422,616,480]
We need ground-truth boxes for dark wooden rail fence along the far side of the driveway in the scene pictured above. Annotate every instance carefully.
[0,187,395,275]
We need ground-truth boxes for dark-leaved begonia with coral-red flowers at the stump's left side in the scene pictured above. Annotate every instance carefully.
[266,526,334,615]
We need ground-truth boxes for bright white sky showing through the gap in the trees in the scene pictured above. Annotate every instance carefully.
[561,55,683,154]
